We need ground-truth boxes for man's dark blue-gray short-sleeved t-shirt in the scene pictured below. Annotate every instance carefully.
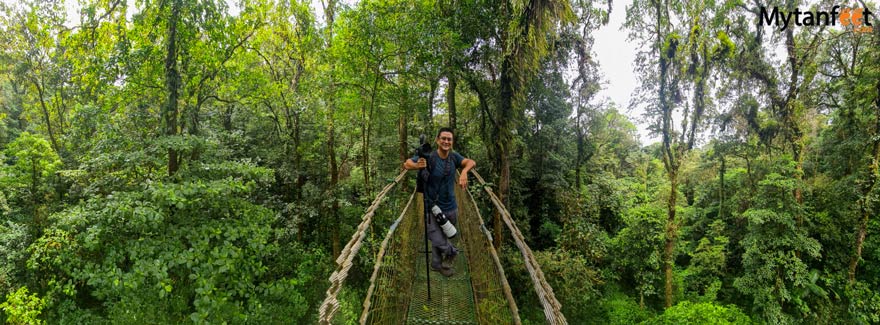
[412,150,464,211]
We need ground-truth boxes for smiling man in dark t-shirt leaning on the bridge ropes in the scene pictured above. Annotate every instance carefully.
[403,128,477,277]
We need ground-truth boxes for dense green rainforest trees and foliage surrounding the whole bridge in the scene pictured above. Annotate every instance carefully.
[0,0,880,324]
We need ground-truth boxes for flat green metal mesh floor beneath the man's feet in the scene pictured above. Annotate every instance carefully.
[407,236,477,324]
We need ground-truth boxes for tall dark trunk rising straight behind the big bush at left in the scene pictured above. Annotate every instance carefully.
[162,0,182,176]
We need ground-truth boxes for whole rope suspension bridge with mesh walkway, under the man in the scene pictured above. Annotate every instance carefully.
[318,170,567,324]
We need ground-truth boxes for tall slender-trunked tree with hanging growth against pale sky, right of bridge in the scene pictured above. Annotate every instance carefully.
[627,0,734,308]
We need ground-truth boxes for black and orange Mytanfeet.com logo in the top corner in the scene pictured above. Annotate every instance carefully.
[758,6,874,33]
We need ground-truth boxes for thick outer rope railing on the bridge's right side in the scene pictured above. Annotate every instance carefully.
[471,170,568,325]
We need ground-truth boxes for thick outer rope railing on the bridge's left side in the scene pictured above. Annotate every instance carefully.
[318,170,407,325]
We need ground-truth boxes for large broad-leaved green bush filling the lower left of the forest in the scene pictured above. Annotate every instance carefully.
[28,170,316,323]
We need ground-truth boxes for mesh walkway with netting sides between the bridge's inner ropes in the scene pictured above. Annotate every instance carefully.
[362,186,520,325]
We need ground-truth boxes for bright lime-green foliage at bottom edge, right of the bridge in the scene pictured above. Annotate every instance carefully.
[642,301,752,324]
